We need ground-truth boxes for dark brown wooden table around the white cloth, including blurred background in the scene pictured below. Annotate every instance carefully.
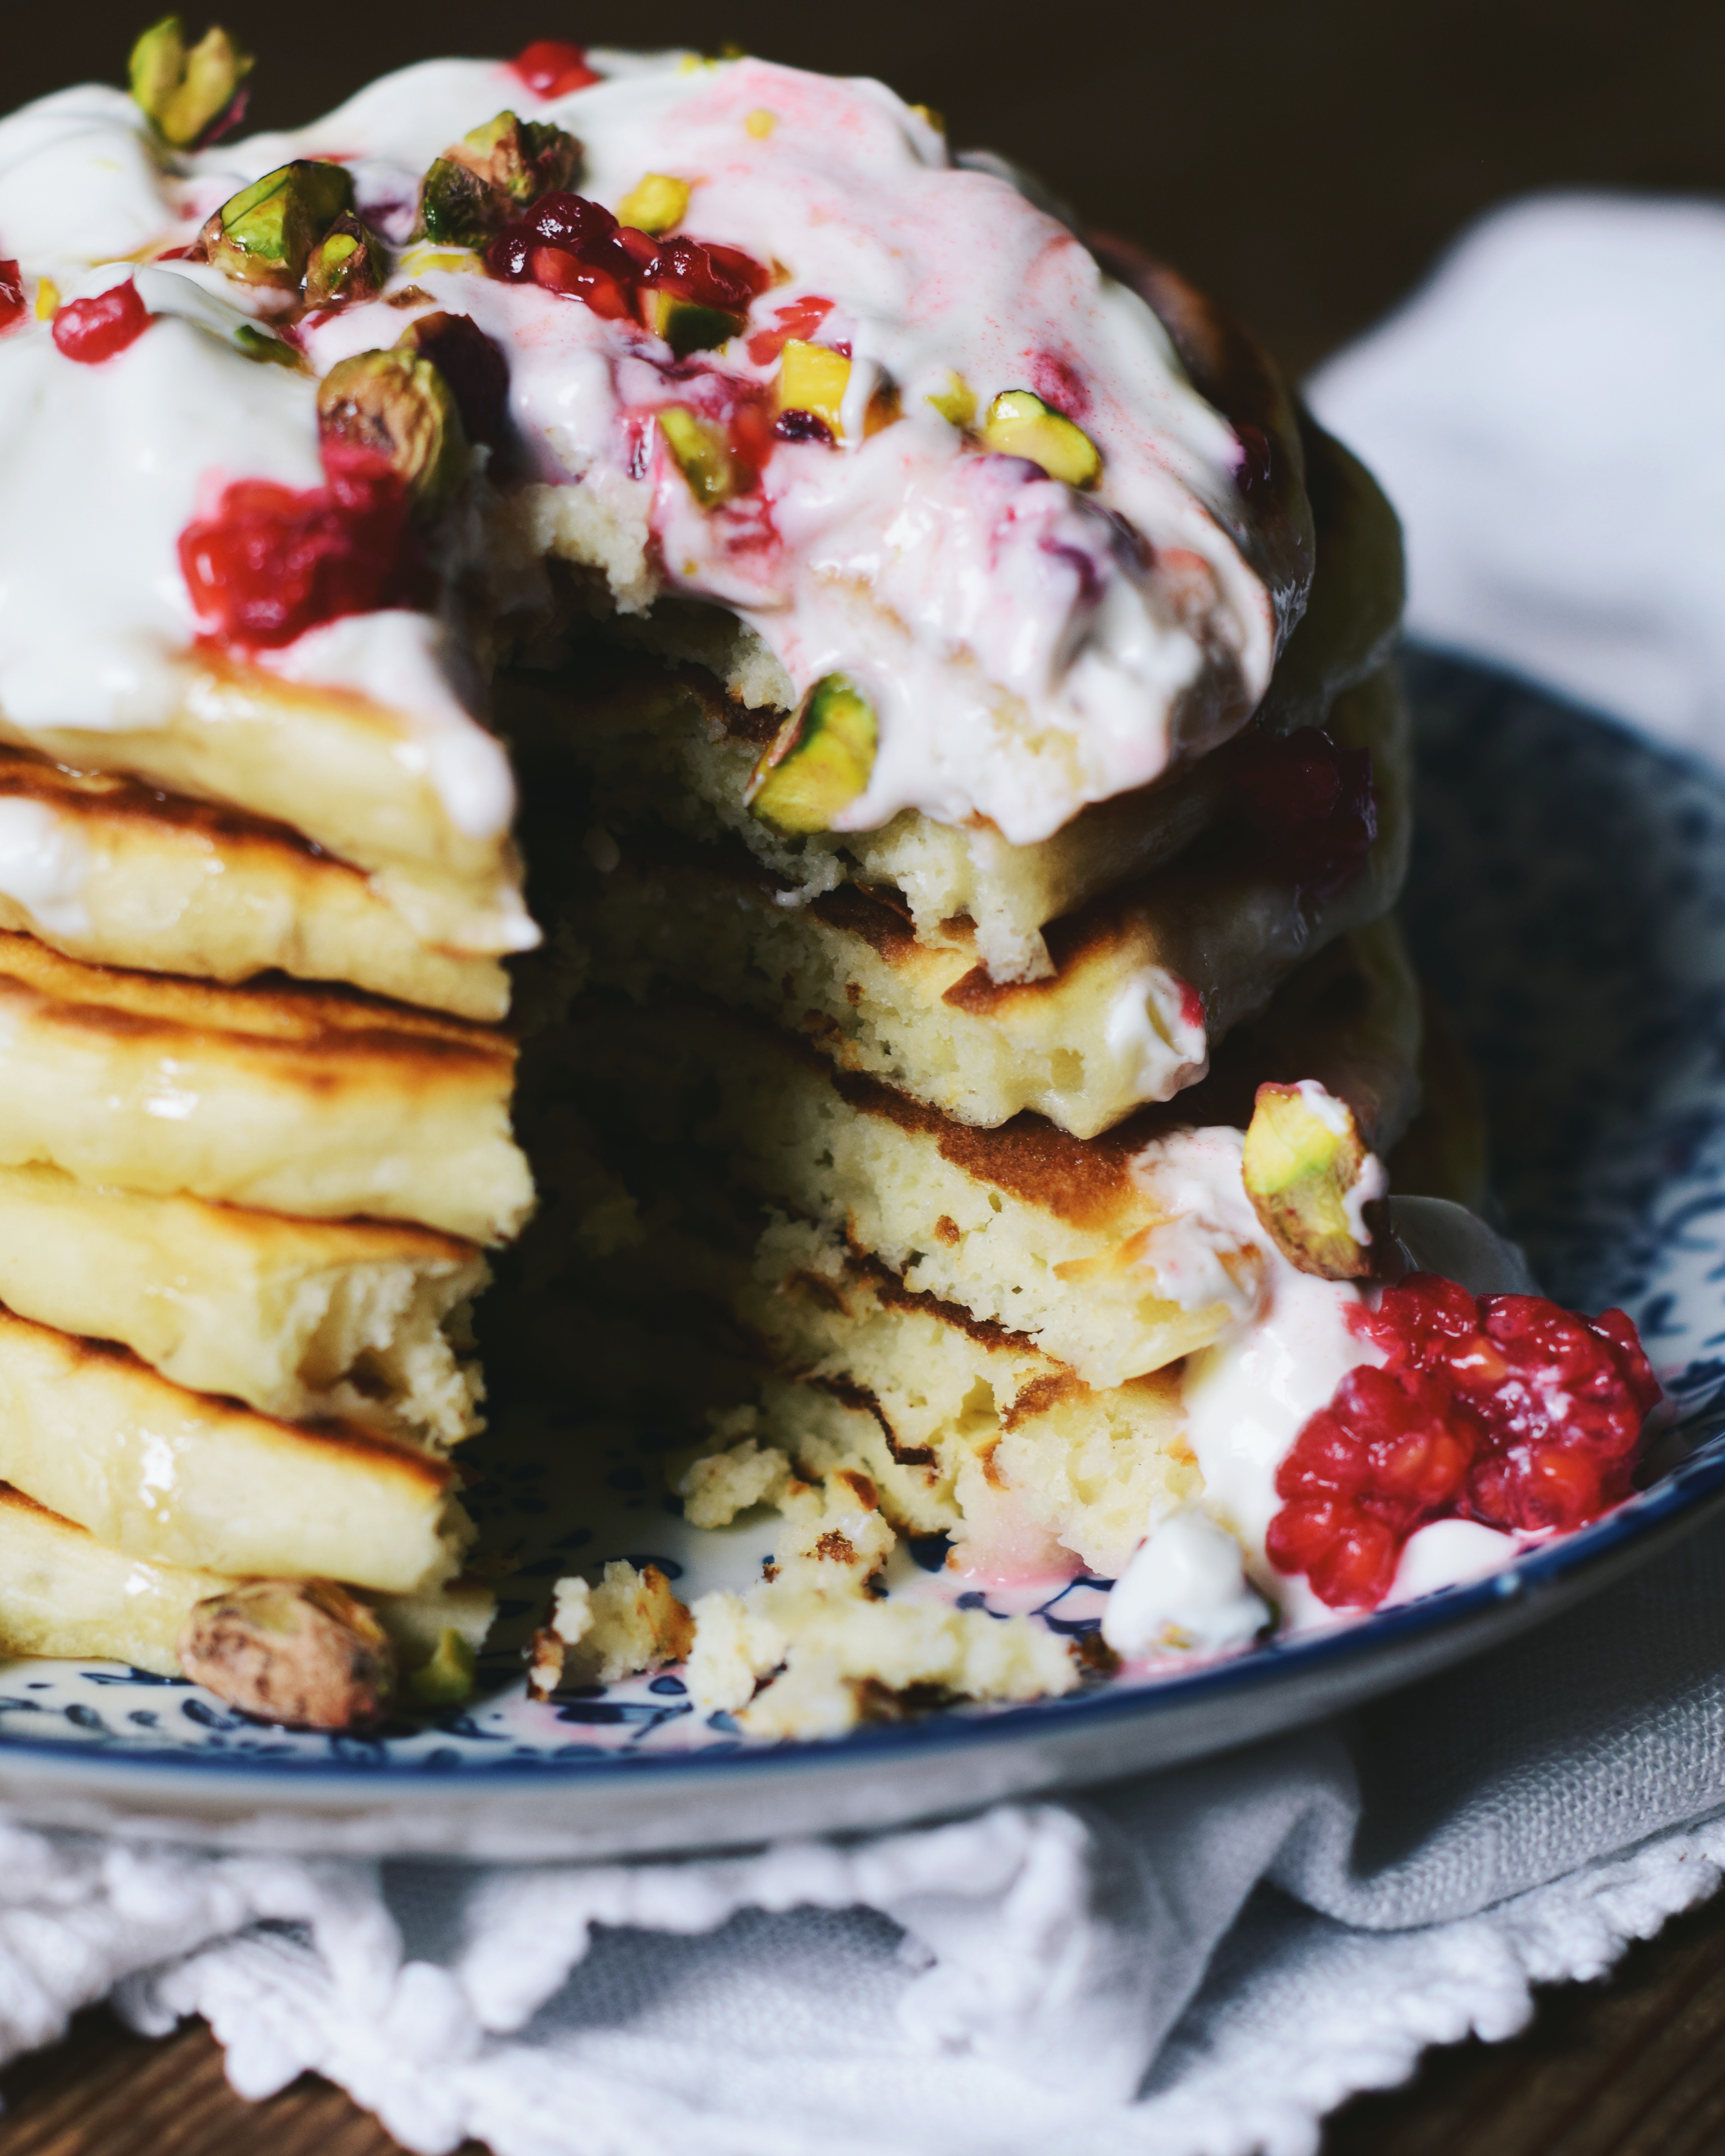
[0,0,1725,2156]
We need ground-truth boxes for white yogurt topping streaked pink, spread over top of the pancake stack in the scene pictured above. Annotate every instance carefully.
[0,56,1276,843]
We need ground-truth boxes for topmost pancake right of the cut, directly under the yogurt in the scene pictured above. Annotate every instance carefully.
[498,423,1402,981]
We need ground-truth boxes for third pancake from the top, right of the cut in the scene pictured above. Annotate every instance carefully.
[550,923,1419,1388]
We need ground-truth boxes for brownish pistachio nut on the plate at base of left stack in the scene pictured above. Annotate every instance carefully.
[179,1580,395,1729]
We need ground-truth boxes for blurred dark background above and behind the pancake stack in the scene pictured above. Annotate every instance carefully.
[13,0,1725,369]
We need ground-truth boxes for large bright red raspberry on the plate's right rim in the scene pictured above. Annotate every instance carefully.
[1266,1272,1660,1608]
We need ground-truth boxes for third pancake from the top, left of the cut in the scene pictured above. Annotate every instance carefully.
[0,936,533,1242]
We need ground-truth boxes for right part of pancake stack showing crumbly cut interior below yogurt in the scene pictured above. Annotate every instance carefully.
[513,367,1423,1736]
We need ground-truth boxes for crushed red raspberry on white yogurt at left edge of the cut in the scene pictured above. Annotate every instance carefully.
[179,442,429,651]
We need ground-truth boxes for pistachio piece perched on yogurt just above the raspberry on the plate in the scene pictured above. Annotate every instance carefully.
[1242,1080,1384,1281]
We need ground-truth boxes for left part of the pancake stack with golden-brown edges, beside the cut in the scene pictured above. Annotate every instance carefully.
[0,664,533,1720]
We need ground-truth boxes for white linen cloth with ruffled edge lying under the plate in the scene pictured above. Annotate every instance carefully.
[0,201,1725,2156]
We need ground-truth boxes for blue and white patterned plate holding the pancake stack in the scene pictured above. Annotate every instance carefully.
[0,655,1725,1858]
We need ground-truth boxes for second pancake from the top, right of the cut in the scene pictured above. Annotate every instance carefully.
[580,673,1410,1138]
